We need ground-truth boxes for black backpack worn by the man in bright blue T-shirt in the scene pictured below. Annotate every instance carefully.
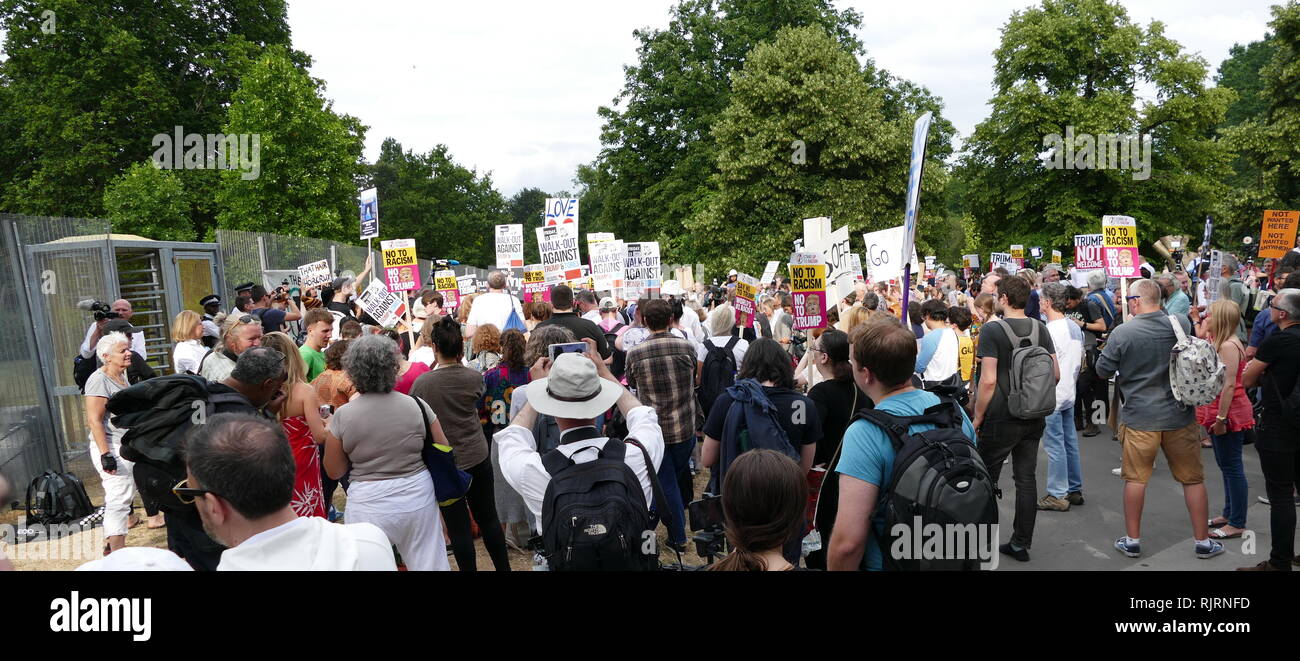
[850,397,997,571]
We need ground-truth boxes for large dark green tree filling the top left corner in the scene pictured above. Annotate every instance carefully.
[0,0,309,233]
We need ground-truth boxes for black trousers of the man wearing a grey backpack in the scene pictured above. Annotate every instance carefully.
[979,419,1047,549]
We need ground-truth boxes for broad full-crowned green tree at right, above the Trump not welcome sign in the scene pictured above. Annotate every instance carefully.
[963,0,1234,257]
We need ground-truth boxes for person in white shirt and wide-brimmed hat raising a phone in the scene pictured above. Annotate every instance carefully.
[493,340,664,533]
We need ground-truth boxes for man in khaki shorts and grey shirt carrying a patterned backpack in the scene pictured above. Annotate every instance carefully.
[1097,280,1223,558]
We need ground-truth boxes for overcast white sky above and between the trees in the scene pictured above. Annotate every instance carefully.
[289,0,1275,195]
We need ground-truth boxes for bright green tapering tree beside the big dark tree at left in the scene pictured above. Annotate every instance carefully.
[216,47,365,242]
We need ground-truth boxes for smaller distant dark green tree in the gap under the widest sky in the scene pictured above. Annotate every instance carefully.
[373,138,506,268]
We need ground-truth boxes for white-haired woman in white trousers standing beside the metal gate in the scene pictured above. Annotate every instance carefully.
[85,332,135,552]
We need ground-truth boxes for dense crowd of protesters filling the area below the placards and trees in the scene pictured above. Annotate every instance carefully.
[7,245,1300,571]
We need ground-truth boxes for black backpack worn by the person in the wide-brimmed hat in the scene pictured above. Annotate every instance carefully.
[542,438,668,571]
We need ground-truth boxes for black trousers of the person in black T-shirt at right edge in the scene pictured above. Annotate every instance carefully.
[1255,414,1300,570]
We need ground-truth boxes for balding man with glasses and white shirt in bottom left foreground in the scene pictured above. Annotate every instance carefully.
[183,414,397,571]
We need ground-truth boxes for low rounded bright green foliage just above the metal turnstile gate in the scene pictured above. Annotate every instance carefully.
[104,161,196,241]
